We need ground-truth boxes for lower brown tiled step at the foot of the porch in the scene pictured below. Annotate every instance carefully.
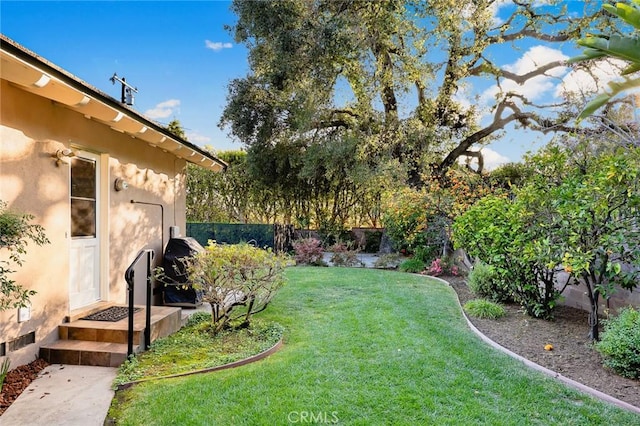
[40,340,140,367]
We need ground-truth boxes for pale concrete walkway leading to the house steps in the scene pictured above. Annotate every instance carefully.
[0,364,117,426]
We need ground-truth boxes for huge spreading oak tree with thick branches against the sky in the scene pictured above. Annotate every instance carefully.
[221,0,607,184]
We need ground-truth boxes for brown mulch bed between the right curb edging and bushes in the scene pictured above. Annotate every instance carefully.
[442,277,640,407]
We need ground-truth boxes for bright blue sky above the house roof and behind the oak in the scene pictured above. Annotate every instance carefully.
[0,0,616,167]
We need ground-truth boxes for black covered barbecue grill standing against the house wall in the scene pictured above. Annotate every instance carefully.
[162,237,204,308]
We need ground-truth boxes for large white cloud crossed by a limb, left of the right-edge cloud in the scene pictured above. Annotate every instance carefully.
[480,46,569,103]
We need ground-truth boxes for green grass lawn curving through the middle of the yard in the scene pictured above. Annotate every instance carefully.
[107,267,640,425]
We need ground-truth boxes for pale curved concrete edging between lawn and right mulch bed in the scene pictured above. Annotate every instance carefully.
[430,276,640,414]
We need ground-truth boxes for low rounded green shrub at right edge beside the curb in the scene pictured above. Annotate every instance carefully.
[595,307,640,379]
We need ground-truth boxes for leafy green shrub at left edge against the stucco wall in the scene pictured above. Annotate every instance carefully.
[0,201,49,311]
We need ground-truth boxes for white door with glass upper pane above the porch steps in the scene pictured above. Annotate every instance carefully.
[69,151,100,310]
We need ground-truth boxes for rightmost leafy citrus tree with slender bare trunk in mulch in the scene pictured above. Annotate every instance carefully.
[550,148,640,340]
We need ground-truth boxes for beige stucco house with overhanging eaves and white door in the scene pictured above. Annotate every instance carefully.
[0,34,226,366]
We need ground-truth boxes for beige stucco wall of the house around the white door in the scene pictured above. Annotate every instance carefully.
[0,81,186,365]
